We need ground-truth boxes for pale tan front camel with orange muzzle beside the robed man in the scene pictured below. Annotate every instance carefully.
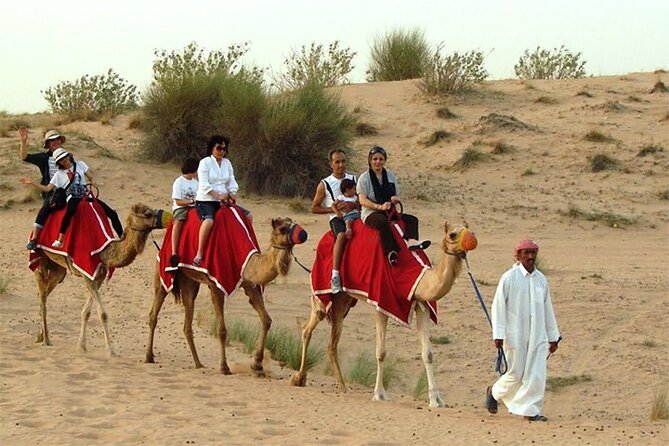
[290,222,476,407]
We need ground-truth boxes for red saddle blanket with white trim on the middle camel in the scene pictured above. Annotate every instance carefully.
[158,206,260,296]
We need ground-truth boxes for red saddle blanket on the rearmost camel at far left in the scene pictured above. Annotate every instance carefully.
[28,200,114,279]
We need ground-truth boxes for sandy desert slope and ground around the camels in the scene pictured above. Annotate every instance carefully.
[0,73,669,445]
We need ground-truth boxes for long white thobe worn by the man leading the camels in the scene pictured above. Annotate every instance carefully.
[492,264,560,416]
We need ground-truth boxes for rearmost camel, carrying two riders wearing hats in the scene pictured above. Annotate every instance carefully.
[35,204,171,356]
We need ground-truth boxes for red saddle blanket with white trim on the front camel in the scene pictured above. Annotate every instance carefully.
[311,220,437,327]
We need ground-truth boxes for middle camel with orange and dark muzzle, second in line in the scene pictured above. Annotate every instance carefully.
[146,218,306,376]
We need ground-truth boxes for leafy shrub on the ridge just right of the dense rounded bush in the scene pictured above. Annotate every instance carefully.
[418,45,488,96]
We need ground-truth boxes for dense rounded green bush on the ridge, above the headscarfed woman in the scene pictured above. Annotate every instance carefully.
[367,28,430,82]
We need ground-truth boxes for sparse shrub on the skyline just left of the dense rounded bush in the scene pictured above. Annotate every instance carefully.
[275,41,356,90]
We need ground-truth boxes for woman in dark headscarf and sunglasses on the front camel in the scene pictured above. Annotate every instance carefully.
[357,146,431,266]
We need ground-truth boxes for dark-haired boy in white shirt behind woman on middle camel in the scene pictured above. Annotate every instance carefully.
[170,158,199,268]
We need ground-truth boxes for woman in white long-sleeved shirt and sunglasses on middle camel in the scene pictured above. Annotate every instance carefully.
[193,135,253,266]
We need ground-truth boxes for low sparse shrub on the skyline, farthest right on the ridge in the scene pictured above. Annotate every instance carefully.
[513,45,585,79]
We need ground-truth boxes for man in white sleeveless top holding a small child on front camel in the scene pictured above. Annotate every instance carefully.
[311,149,360,294]
